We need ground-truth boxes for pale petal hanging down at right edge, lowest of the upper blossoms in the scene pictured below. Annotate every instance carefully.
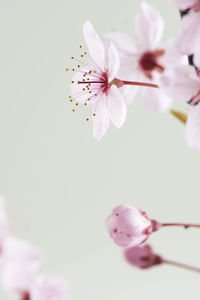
[185,105,200,150]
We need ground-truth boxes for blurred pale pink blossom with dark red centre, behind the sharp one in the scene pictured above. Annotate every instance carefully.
[105,2,183,112]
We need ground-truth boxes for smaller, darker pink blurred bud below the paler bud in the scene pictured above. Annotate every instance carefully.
[124,245,163,269]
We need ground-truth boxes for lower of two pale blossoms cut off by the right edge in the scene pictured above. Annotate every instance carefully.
[161,66,200,150]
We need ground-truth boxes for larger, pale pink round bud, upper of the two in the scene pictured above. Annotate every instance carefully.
[106,205,161,248]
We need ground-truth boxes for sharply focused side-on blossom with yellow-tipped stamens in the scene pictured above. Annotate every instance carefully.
[71,21,127,140]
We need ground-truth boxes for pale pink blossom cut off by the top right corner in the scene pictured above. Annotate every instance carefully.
[170,0,200,67]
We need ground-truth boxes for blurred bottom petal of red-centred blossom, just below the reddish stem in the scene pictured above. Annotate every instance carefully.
[142,88,172,113]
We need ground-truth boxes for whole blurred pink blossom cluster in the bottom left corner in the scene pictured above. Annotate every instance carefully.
[0,197,68,300]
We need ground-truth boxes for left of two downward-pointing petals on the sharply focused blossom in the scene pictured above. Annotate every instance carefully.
[93,96,109,140]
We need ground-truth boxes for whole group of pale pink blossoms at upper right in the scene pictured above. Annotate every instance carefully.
[67,0,200,149]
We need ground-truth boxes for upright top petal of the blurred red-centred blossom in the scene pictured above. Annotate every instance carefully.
[136,2,164,50]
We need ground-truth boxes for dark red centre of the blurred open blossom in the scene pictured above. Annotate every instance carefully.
[139,50,164,79]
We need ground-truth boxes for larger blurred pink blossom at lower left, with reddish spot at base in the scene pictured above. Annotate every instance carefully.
[1,237,41,300]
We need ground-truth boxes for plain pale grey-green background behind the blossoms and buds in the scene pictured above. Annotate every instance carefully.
[0,0,200,300]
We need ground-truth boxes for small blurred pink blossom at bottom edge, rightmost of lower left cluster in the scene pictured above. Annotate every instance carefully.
[31,275,68,300]
